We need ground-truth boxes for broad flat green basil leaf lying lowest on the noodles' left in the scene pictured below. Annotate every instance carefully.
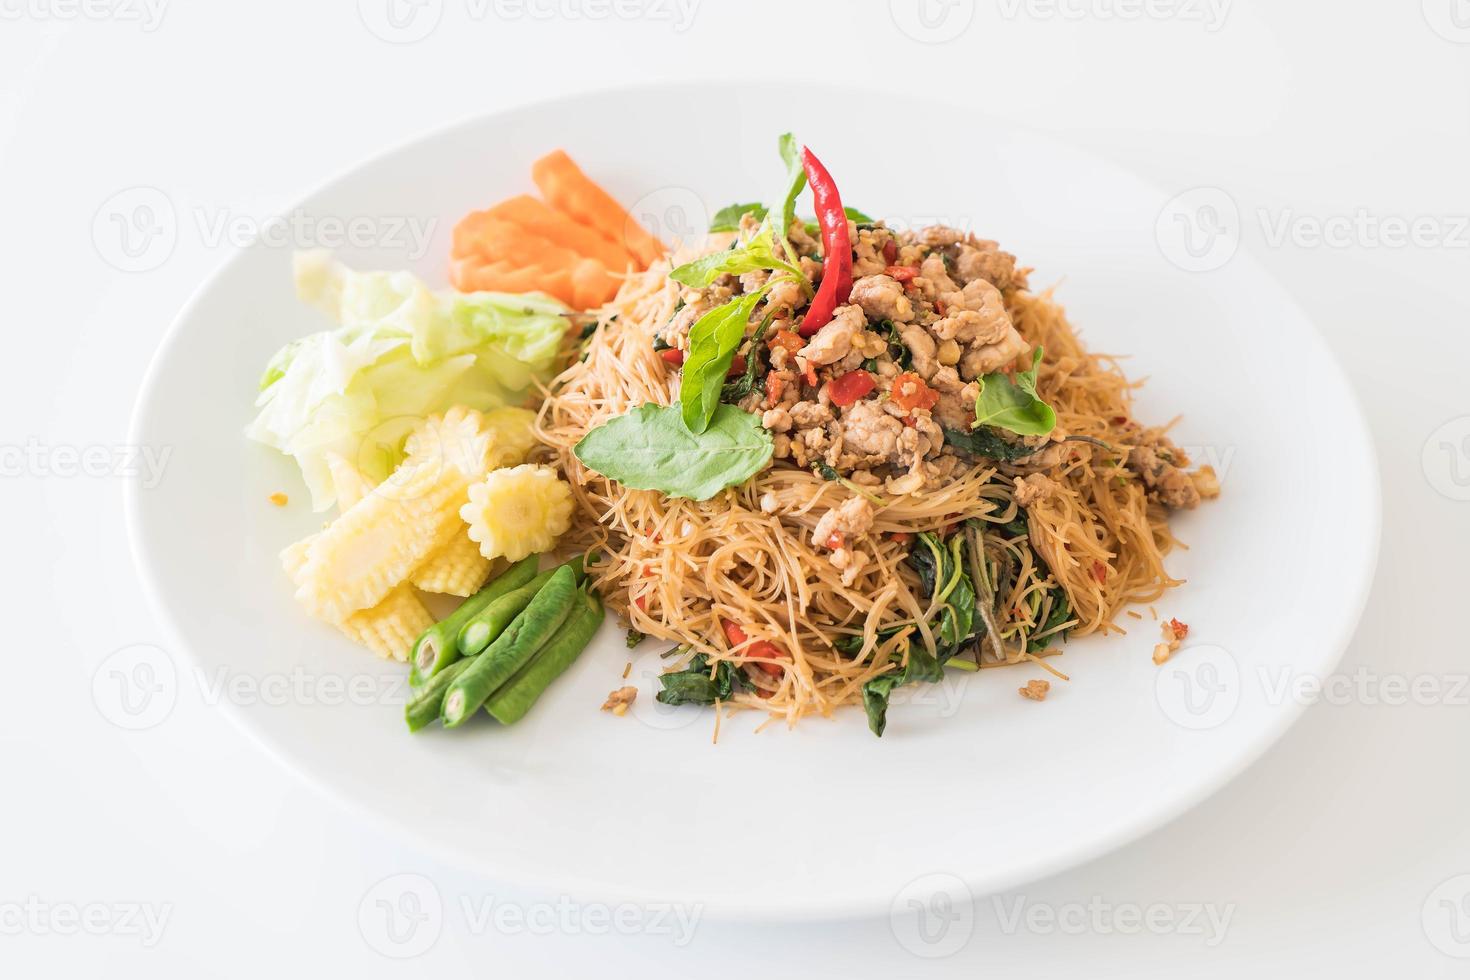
[573,404,775,500]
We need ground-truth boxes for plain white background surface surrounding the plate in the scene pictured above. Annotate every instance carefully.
[0,0,1470,977]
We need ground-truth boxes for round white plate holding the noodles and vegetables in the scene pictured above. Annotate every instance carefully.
[128,85,1379,918]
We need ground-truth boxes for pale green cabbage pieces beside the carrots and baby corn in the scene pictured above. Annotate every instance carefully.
[245,250,567,510]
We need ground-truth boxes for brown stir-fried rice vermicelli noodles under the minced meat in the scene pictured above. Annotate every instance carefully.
[537,262,1179,723]
